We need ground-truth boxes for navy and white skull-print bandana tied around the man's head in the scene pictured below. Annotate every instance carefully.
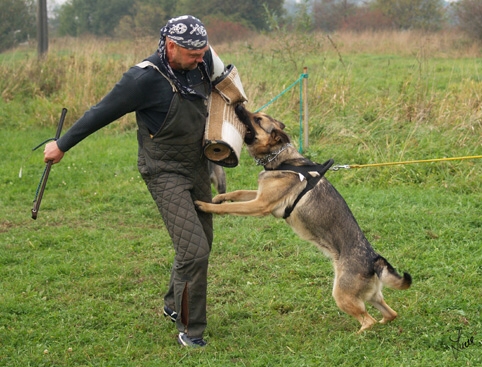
[157,15,208,99]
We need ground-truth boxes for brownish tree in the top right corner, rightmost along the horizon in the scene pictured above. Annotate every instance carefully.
[453,0,482,41]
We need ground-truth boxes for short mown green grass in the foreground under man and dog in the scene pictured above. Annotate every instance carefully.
[0,130,482,366]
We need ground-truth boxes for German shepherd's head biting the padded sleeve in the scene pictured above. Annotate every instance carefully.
[235,104,290,155]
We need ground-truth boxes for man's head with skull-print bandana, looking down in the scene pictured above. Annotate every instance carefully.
[159,15,209,70]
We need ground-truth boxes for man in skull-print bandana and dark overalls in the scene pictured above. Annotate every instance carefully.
[44,15,240,347]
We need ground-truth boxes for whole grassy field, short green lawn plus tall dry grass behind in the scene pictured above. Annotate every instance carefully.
[0,30,482,367]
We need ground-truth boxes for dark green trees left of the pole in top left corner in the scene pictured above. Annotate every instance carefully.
[0,0,37,52]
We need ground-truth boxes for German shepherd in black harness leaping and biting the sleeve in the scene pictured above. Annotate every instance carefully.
[196,105,412,333]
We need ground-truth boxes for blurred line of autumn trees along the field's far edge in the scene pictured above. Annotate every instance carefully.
[0,0,482,52]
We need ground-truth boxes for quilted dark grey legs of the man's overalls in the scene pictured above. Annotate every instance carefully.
[148,174,213,337]
